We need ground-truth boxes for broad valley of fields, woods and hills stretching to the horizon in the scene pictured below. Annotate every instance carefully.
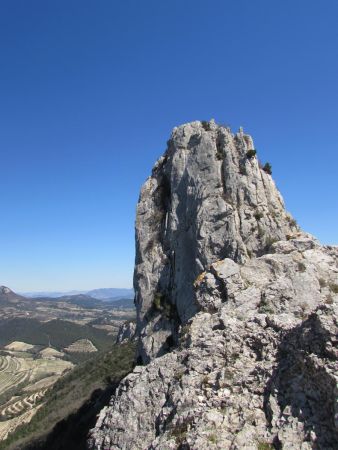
[0,287,135,449]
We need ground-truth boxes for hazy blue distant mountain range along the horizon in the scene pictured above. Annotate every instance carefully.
[21,288,134,300]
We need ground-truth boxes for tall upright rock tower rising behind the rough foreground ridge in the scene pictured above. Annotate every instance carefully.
[134,122,295,362]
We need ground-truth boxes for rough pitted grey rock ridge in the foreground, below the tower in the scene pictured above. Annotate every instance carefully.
[91,237,338,450]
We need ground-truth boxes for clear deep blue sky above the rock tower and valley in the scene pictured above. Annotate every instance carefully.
[0,0,338,290]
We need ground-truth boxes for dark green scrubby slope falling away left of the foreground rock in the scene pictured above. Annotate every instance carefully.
[0,342,135,450]
